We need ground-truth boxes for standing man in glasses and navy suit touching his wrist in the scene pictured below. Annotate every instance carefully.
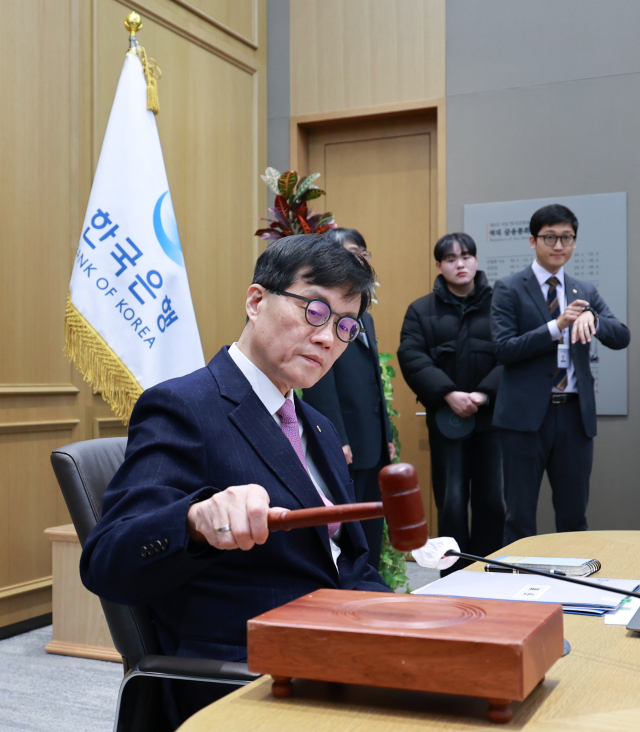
[491,204,630,544]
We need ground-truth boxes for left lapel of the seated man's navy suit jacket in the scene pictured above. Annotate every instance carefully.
[209,349,322,508]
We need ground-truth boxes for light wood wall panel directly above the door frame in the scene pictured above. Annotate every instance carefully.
[291,0,445,116]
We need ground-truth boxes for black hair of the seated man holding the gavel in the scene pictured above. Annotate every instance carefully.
[253,234,375,316]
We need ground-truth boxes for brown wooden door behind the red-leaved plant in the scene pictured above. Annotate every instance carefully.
[300,110,437,535]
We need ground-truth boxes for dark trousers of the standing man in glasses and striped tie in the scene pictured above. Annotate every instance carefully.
[500,399,593,545]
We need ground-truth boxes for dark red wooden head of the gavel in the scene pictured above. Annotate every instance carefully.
[378,463,429,552]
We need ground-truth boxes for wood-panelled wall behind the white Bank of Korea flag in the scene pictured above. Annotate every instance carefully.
[0,0,266,626]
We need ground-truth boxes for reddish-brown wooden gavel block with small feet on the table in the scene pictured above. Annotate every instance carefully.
[247,589,564,723]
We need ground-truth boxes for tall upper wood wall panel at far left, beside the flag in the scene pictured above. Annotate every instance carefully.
[0,1,73,384]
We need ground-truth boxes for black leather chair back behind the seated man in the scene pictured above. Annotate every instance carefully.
[51,437,161,671]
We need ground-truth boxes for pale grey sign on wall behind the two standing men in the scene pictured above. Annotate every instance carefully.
[464,193,628,415]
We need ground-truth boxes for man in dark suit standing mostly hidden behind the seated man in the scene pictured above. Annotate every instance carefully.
[304,228,395,567]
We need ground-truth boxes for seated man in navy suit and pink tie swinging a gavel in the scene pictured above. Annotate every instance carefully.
[81,235,389,720]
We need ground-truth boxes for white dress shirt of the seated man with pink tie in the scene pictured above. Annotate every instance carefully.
[229,343,342,567]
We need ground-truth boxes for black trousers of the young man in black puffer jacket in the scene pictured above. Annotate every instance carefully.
[429,429,505,556]
